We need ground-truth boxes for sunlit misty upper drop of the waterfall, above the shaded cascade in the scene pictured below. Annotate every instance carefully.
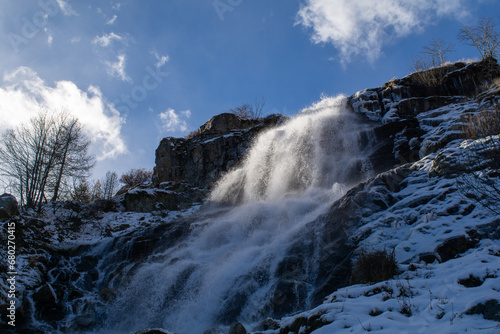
[211,96,371,204]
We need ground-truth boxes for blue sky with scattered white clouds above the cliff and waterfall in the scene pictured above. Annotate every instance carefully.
[0,0,500,177]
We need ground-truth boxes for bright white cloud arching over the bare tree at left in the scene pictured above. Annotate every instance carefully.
[0,67,126,160]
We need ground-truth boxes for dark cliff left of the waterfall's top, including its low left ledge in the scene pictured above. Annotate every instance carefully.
[120,113,285,212]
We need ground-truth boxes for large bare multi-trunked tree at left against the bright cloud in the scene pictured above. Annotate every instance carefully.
[0,112,93,210]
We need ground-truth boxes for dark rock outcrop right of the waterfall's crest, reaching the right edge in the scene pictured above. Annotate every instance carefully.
[349,58,500,173]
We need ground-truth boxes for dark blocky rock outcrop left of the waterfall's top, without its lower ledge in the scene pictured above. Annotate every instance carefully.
[153,113,284,188]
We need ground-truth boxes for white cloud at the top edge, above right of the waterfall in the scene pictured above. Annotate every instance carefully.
[296,0,466,64]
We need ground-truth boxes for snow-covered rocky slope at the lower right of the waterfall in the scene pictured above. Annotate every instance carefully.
[268,144,500,334]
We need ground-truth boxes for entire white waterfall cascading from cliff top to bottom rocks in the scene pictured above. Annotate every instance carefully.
[100,97,376,334]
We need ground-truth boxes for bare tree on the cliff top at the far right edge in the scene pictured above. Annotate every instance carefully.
[458,17,500,59]
